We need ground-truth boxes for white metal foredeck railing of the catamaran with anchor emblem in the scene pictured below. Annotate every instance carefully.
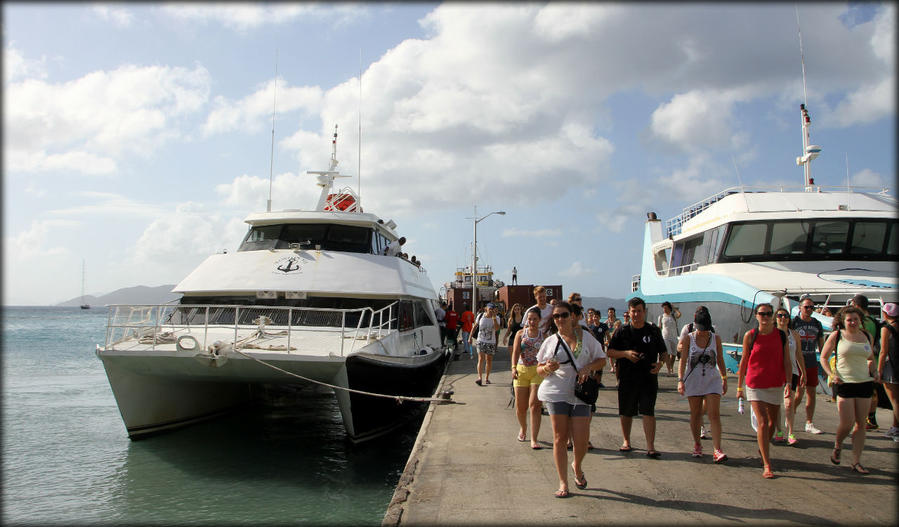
[106,302,399,356]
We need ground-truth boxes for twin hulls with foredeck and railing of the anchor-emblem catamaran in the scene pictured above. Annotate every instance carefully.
[97,305,446,441]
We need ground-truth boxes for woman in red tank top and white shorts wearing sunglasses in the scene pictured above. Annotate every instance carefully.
[737,304,793,479]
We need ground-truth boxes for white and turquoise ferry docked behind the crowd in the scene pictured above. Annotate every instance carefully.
[628,104,899,365]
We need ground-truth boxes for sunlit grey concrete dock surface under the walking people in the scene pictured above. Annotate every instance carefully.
[383,348,899,525]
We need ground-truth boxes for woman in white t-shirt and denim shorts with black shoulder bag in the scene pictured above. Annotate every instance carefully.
[537,302,606,498]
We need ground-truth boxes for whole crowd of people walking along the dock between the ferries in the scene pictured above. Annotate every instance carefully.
[438,286,899,498]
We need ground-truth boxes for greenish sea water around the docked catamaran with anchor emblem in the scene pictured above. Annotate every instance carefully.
[2,307,420,525]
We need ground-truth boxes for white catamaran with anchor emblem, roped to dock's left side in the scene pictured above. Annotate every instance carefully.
[96,127,446,441]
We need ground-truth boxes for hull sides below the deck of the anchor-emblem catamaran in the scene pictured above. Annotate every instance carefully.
[97,344,446,442]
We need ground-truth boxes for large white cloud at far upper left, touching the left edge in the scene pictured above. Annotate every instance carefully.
[3,59,210,174]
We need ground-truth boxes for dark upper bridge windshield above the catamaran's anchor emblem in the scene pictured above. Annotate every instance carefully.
[237,223,373,253]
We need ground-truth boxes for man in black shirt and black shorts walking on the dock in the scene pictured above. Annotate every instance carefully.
[607,297,667,458]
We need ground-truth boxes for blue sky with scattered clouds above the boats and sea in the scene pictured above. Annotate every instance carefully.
[2,2,896,305]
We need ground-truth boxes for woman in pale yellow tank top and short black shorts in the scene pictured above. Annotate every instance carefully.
[821,306,879,474]
